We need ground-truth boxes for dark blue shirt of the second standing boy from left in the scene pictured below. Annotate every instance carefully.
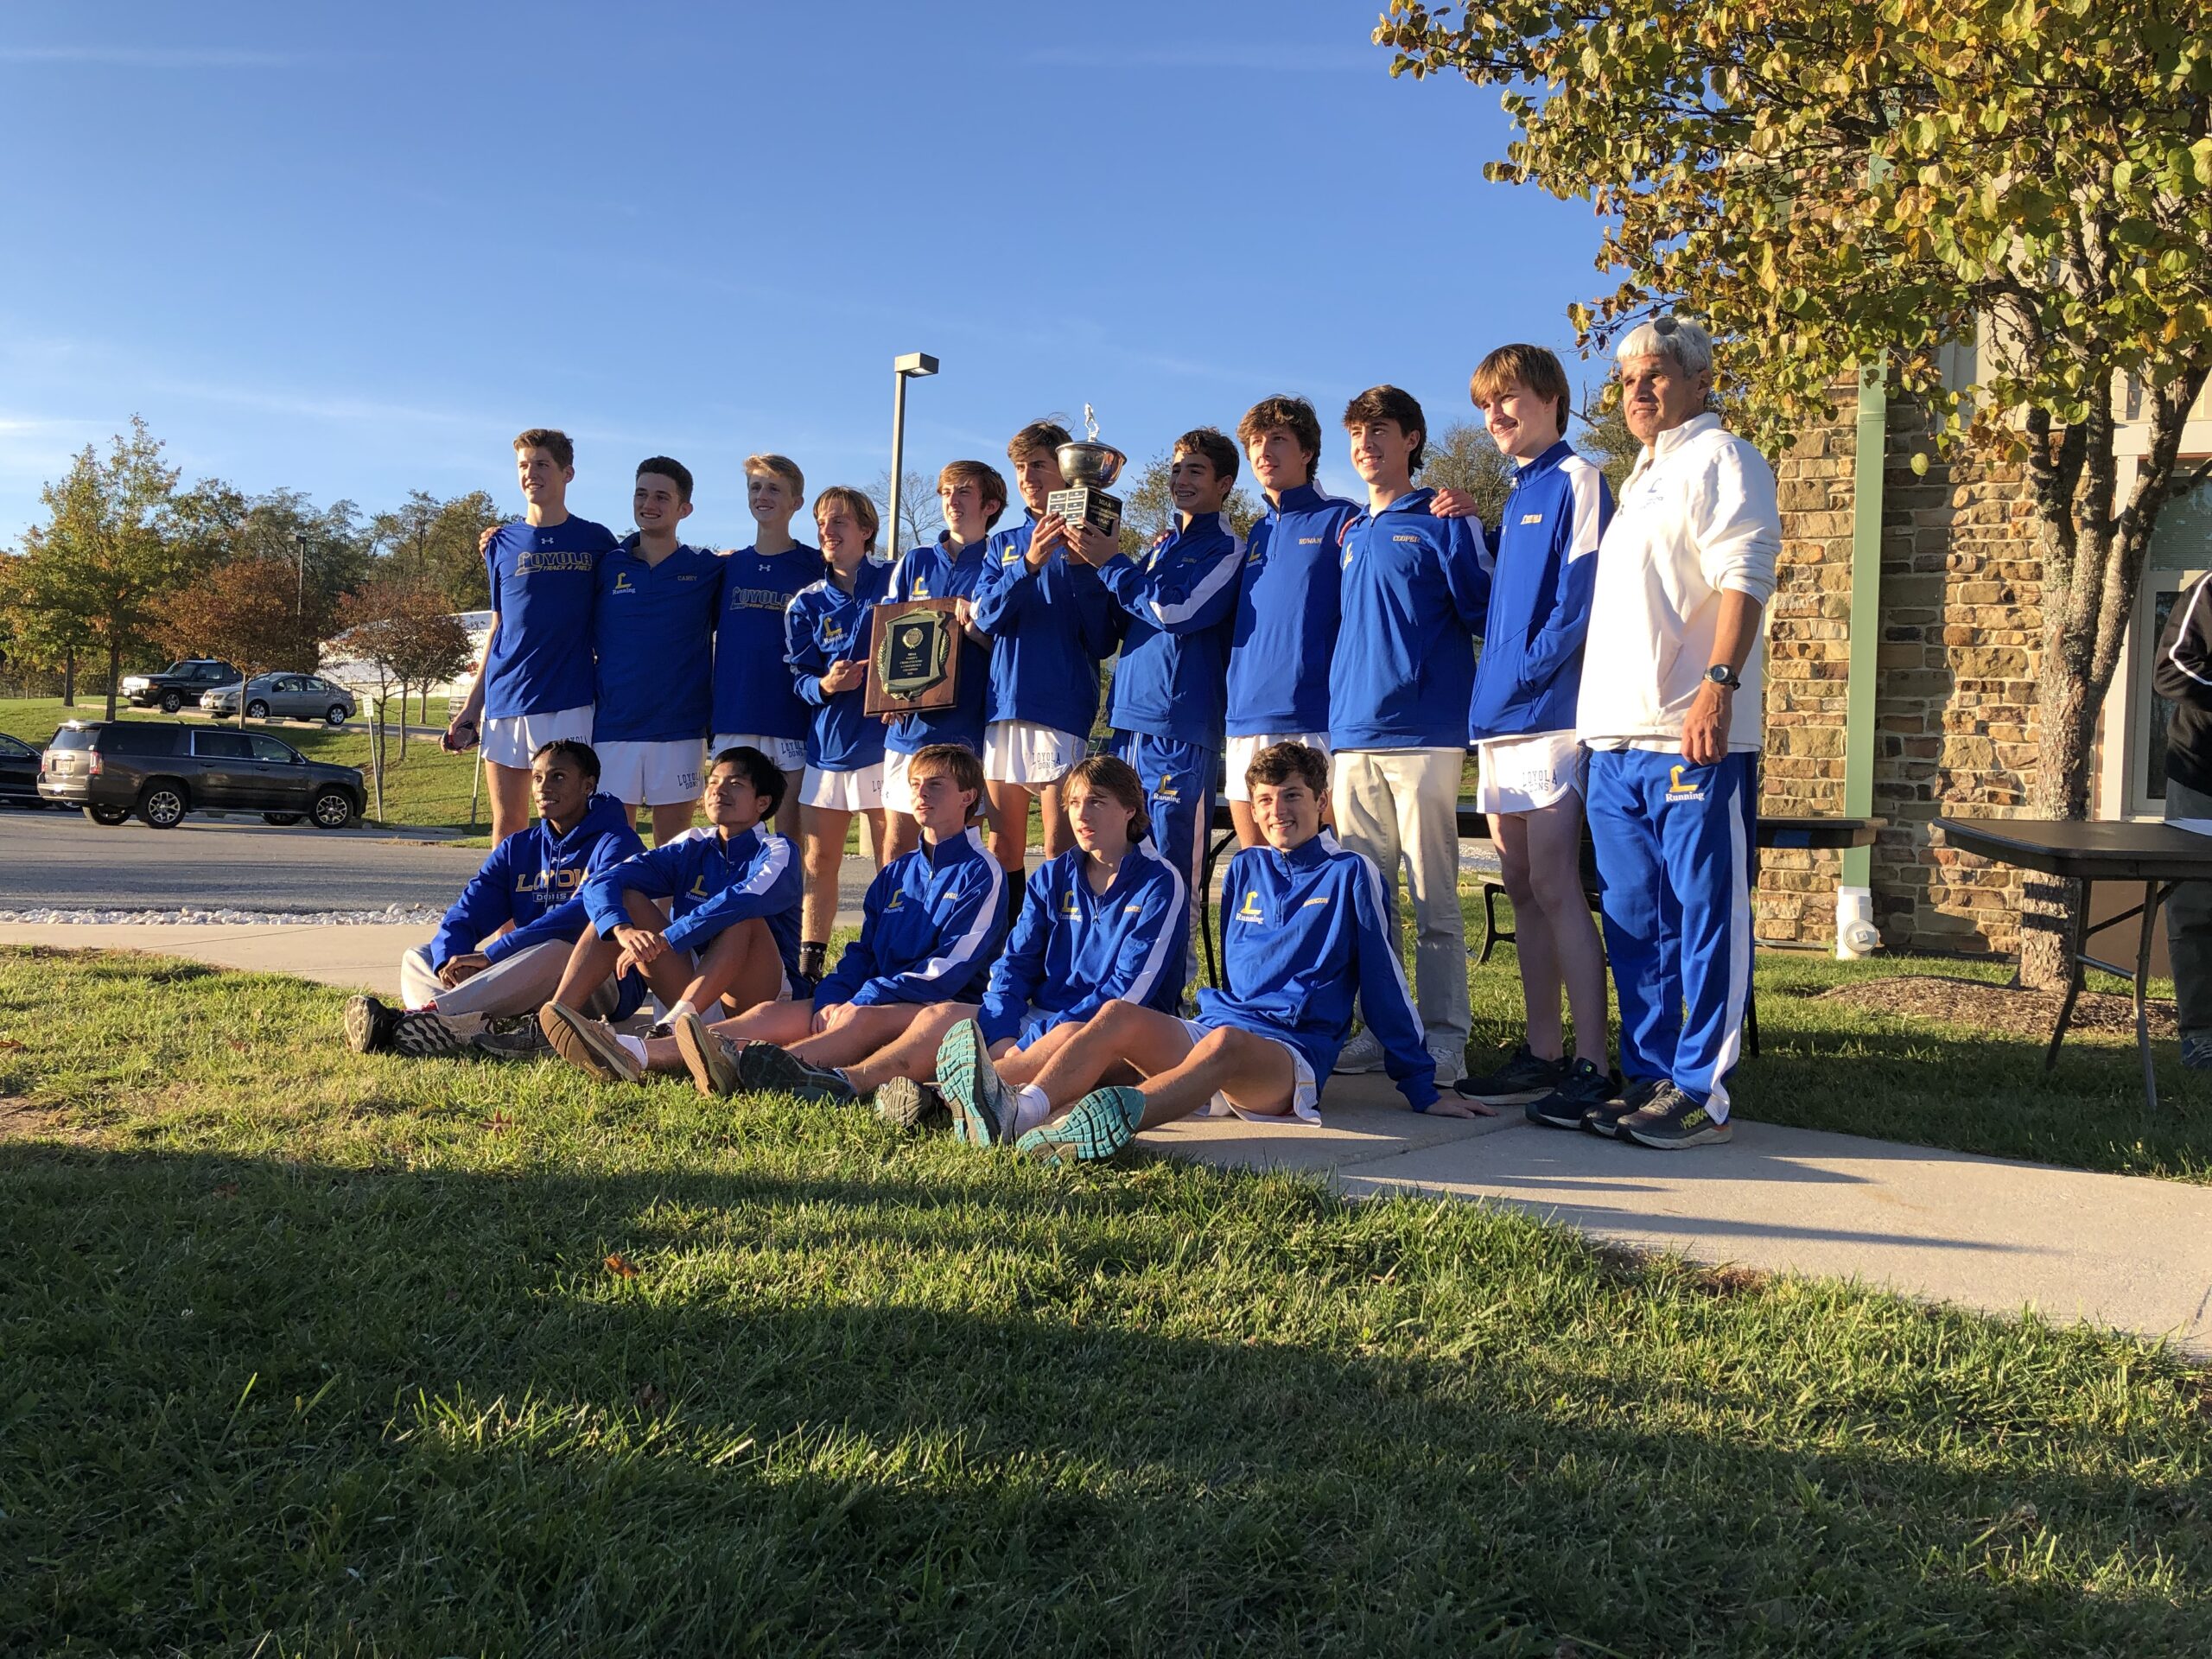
[591,536,723,743]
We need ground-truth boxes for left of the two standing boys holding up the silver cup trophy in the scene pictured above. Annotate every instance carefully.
[973,420,1115,892]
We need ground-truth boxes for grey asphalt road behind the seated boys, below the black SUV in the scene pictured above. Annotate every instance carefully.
[0,807,874,927]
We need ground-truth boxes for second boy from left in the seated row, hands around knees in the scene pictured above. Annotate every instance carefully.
[537,750,798,1059]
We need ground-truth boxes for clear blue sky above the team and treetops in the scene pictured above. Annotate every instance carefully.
[0,0,1604,544]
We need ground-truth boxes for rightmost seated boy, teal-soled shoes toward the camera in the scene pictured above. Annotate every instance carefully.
[938,743,1433,1164]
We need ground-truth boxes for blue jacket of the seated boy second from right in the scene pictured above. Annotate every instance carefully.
[976,841,1185,1046]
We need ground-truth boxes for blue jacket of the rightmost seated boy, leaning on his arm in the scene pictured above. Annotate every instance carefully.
[1199,830,1435,1113]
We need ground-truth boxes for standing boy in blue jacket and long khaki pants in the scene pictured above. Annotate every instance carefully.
[1330,385,1491,1084]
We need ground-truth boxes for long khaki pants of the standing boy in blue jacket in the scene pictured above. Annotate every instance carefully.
[1330,750,1469,1053]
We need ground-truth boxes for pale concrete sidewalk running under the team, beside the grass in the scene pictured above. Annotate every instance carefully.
[0,925,2212,1354]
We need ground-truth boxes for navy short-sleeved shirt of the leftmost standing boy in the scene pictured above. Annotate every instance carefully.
[485,518,615,721]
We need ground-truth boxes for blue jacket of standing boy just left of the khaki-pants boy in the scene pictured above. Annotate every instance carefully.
[1228,485,1360,736]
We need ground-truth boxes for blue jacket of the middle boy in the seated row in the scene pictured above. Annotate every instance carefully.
[814,830,1007,1008]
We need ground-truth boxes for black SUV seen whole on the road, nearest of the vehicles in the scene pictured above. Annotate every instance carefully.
[38,721,365,830]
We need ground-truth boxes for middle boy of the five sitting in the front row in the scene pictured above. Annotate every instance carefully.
[546,743,1007,1095]
